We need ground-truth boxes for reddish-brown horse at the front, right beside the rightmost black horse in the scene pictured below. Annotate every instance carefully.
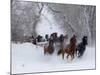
[64,35,77,60]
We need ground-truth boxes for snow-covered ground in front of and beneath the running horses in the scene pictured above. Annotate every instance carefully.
[12,43,95,74]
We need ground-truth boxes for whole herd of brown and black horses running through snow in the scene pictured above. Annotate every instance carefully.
[32,33,88,60]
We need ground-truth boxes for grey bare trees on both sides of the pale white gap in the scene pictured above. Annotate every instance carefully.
[11,0,96,43]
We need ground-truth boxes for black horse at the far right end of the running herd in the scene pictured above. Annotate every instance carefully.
[76,36,88,57]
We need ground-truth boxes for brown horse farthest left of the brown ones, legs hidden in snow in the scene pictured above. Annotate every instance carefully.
[44,39,54,54]
